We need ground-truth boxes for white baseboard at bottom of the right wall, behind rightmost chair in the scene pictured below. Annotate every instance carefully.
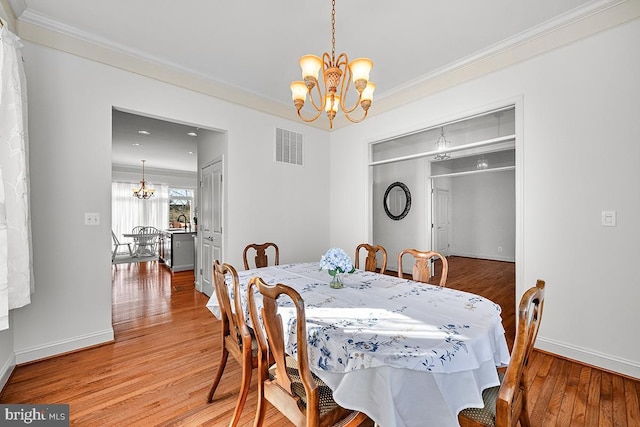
[536,336,640,379]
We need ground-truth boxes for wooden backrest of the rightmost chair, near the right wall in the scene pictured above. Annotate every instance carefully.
[496,280,545,427]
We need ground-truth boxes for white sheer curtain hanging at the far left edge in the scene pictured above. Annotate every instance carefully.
[0,21,34,330]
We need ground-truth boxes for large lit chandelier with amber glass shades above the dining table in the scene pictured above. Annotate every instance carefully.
[291,0,376,128]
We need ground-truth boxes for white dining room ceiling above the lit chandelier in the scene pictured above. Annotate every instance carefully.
[5,0,614,173]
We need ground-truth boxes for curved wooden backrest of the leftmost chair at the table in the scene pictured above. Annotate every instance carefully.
[213,260,251,349]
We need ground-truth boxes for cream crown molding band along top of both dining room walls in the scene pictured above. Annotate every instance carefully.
[6,0,640,130]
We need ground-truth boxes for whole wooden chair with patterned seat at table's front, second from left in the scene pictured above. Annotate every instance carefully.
[247,277,368,427]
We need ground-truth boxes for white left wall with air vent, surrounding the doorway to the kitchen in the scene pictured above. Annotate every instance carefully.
[6,42,329,366]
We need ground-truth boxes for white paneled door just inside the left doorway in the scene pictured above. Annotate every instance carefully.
[198,161,222,296]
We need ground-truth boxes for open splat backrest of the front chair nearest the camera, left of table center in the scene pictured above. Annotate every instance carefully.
[247,277,320,426]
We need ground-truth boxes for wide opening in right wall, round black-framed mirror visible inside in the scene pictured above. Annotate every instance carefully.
[369,101,522,342]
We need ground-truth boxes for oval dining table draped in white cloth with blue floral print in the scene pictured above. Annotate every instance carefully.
[207,262,510,427]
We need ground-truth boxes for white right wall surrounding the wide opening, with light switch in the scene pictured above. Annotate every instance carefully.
[331,19,640,377]
